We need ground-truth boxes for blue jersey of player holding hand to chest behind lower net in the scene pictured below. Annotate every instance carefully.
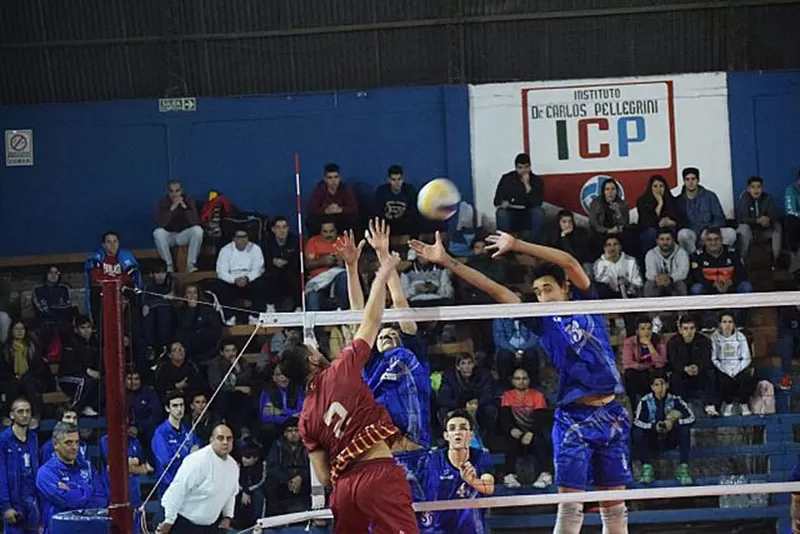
[420,448,492,534]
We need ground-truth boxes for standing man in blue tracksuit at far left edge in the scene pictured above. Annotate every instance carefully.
[0,399,40,534]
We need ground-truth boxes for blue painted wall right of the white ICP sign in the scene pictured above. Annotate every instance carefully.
[728,71,800,209]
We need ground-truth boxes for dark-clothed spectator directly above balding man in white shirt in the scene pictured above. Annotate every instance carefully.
[208,338,254,433]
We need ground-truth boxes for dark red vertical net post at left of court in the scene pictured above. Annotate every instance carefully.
[101,279,133,534]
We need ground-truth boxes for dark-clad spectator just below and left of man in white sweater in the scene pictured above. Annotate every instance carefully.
[176,284,222,363]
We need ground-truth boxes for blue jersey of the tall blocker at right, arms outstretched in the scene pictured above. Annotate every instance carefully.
[539,288,624,406]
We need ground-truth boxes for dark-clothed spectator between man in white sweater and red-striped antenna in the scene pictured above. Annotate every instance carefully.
[264,215,301,312]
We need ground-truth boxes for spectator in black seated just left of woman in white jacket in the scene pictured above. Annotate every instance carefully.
[667,315,719,416]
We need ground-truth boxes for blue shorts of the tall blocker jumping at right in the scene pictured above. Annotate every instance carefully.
[553,401,631,490]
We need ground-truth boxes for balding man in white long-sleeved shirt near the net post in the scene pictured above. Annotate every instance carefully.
[156,425,239,534]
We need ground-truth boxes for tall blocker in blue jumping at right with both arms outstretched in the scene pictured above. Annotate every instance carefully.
[409,232,631,534]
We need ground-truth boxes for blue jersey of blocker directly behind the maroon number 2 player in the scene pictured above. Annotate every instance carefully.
[363,347,431,447]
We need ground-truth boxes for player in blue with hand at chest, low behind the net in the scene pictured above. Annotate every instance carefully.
[419,410,494,534]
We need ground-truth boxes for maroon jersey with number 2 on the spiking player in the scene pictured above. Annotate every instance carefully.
[299,339,399,482]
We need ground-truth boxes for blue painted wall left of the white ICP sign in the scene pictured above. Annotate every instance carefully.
[0,86,472,256]
